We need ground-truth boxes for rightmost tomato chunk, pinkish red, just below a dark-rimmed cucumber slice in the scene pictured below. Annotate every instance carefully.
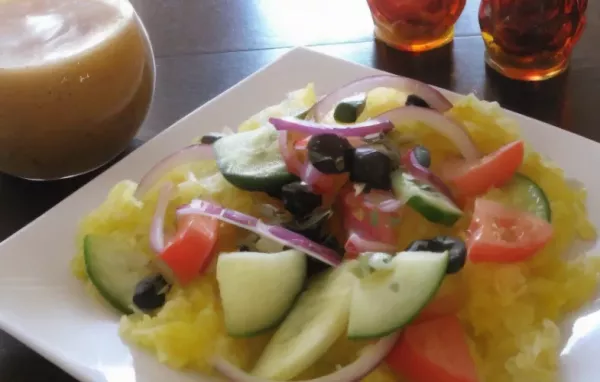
[467,199,553,263]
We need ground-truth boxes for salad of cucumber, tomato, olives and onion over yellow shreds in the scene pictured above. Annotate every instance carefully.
[72,75,600,382]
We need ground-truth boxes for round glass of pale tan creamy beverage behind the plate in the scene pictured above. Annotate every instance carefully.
[0,0,155,180]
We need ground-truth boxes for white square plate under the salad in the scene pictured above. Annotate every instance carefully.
[0,48,600,382]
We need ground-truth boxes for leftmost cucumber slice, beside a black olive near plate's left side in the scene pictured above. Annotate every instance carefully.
[83,235,151,314]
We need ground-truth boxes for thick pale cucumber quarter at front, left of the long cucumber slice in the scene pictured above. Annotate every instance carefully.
[217,250,306,337]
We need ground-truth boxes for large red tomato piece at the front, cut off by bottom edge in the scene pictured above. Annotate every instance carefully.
[386,316,479,382]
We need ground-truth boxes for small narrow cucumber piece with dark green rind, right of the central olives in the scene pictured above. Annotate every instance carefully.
[392,172,463,226]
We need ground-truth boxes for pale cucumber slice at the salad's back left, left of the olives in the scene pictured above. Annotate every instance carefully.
[213,125,297,191]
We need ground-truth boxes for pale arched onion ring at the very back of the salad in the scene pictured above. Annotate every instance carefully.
[309,74,452,121]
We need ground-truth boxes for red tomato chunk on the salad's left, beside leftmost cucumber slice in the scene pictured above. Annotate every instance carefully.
[158,215,219,285]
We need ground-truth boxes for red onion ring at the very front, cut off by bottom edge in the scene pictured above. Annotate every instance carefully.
[212,333,399,382]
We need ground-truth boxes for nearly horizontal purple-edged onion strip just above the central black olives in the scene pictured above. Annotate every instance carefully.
[269,117,394,137]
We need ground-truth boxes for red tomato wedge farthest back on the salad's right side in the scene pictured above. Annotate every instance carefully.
[442,141,525,196]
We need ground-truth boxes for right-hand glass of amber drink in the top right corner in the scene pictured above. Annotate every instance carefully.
[479,0,587,81]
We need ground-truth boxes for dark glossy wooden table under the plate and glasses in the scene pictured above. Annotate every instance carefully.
[0,0,600,382]
